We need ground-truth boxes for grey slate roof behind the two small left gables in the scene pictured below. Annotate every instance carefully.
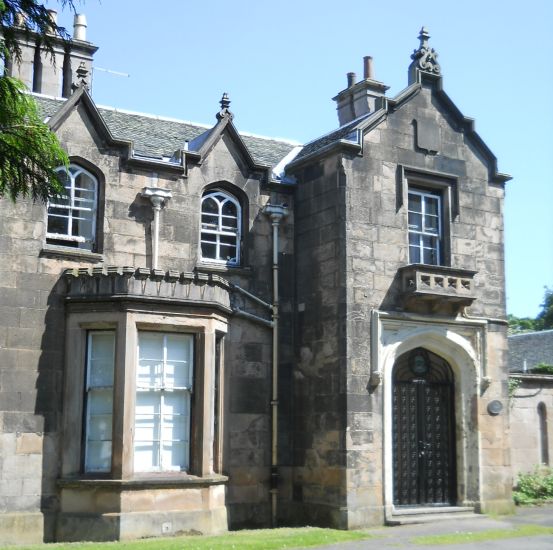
[35,95,297,166]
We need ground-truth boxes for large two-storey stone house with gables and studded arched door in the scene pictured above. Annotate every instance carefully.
[0,20,512,542]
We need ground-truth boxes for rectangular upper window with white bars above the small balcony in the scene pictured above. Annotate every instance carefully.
[408,187,443,265]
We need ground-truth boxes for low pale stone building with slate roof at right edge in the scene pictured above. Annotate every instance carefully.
[508,330,553,474]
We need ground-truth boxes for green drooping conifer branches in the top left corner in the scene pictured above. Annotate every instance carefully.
[0,0,73,201]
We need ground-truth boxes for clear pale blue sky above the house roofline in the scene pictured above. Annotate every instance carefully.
[52,0,553,316]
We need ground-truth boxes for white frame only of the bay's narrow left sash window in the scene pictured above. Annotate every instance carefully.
[84,330,116,473]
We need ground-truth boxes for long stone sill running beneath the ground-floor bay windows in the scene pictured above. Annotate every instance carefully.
[57,474,228,490]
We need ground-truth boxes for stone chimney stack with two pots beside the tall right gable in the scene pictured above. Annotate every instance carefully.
[333,55,388,126]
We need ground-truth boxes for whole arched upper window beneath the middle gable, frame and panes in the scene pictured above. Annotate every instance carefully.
[200,189,242,265]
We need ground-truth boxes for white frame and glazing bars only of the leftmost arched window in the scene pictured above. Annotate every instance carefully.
[46,164,98,250]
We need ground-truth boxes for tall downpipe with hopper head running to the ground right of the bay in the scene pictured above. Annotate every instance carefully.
[263,204,288,527]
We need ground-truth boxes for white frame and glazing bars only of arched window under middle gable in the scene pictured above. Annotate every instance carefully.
[200,189,242,265]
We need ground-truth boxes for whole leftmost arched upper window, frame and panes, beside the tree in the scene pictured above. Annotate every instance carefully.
[46,164,98,250]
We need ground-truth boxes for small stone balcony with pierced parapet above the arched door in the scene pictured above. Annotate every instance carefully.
[398,264,477,314]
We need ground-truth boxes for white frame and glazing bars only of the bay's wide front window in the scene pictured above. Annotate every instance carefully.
[133,330,195,473]
